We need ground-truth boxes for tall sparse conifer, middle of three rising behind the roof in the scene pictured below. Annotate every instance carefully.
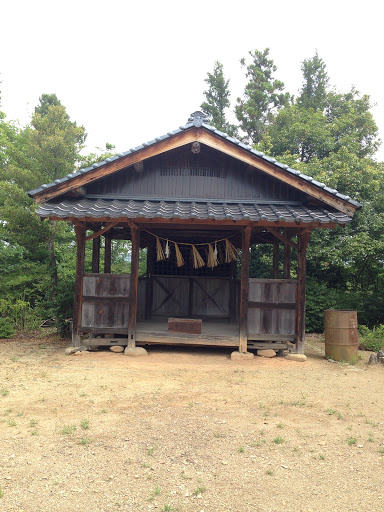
[235,48,290,144]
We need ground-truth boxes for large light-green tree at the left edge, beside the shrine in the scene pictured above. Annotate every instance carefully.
[0,95,85,330]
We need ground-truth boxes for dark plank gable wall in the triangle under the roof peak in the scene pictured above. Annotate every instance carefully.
[87,145,303,201]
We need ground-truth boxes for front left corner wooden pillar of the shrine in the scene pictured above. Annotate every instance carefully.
[72,224,86,347]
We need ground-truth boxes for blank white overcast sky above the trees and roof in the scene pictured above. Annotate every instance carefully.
[0,0,384,160]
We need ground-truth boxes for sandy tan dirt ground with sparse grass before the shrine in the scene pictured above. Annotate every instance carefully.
[0,333,384,512]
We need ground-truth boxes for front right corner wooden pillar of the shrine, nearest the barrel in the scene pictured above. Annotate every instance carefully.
[296,230,311,354]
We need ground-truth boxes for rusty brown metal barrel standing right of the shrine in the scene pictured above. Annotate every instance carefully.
[324,309,359,361]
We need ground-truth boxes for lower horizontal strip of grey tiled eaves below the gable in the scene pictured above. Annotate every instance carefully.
[37,199,351,224]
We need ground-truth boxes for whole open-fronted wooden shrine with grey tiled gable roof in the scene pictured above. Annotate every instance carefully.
[29,112,361,353]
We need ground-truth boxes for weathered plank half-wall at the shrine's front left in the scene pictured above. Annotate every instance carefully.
[81,274,130,330]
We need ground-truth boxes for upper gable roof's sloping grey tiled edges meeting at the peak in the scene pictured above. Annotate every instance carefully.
[28,112,361,208]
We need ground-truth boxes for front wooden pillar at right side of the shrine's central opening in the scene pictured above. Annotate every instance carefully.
[239,226,252,353]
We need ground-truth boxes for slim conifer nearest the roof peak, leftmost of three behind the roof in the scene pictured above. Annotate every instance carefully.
[201,61,236,135]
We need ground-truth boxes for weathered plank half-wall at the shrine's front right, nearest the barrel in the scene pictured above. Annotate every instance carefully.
[248,279,297,340]
